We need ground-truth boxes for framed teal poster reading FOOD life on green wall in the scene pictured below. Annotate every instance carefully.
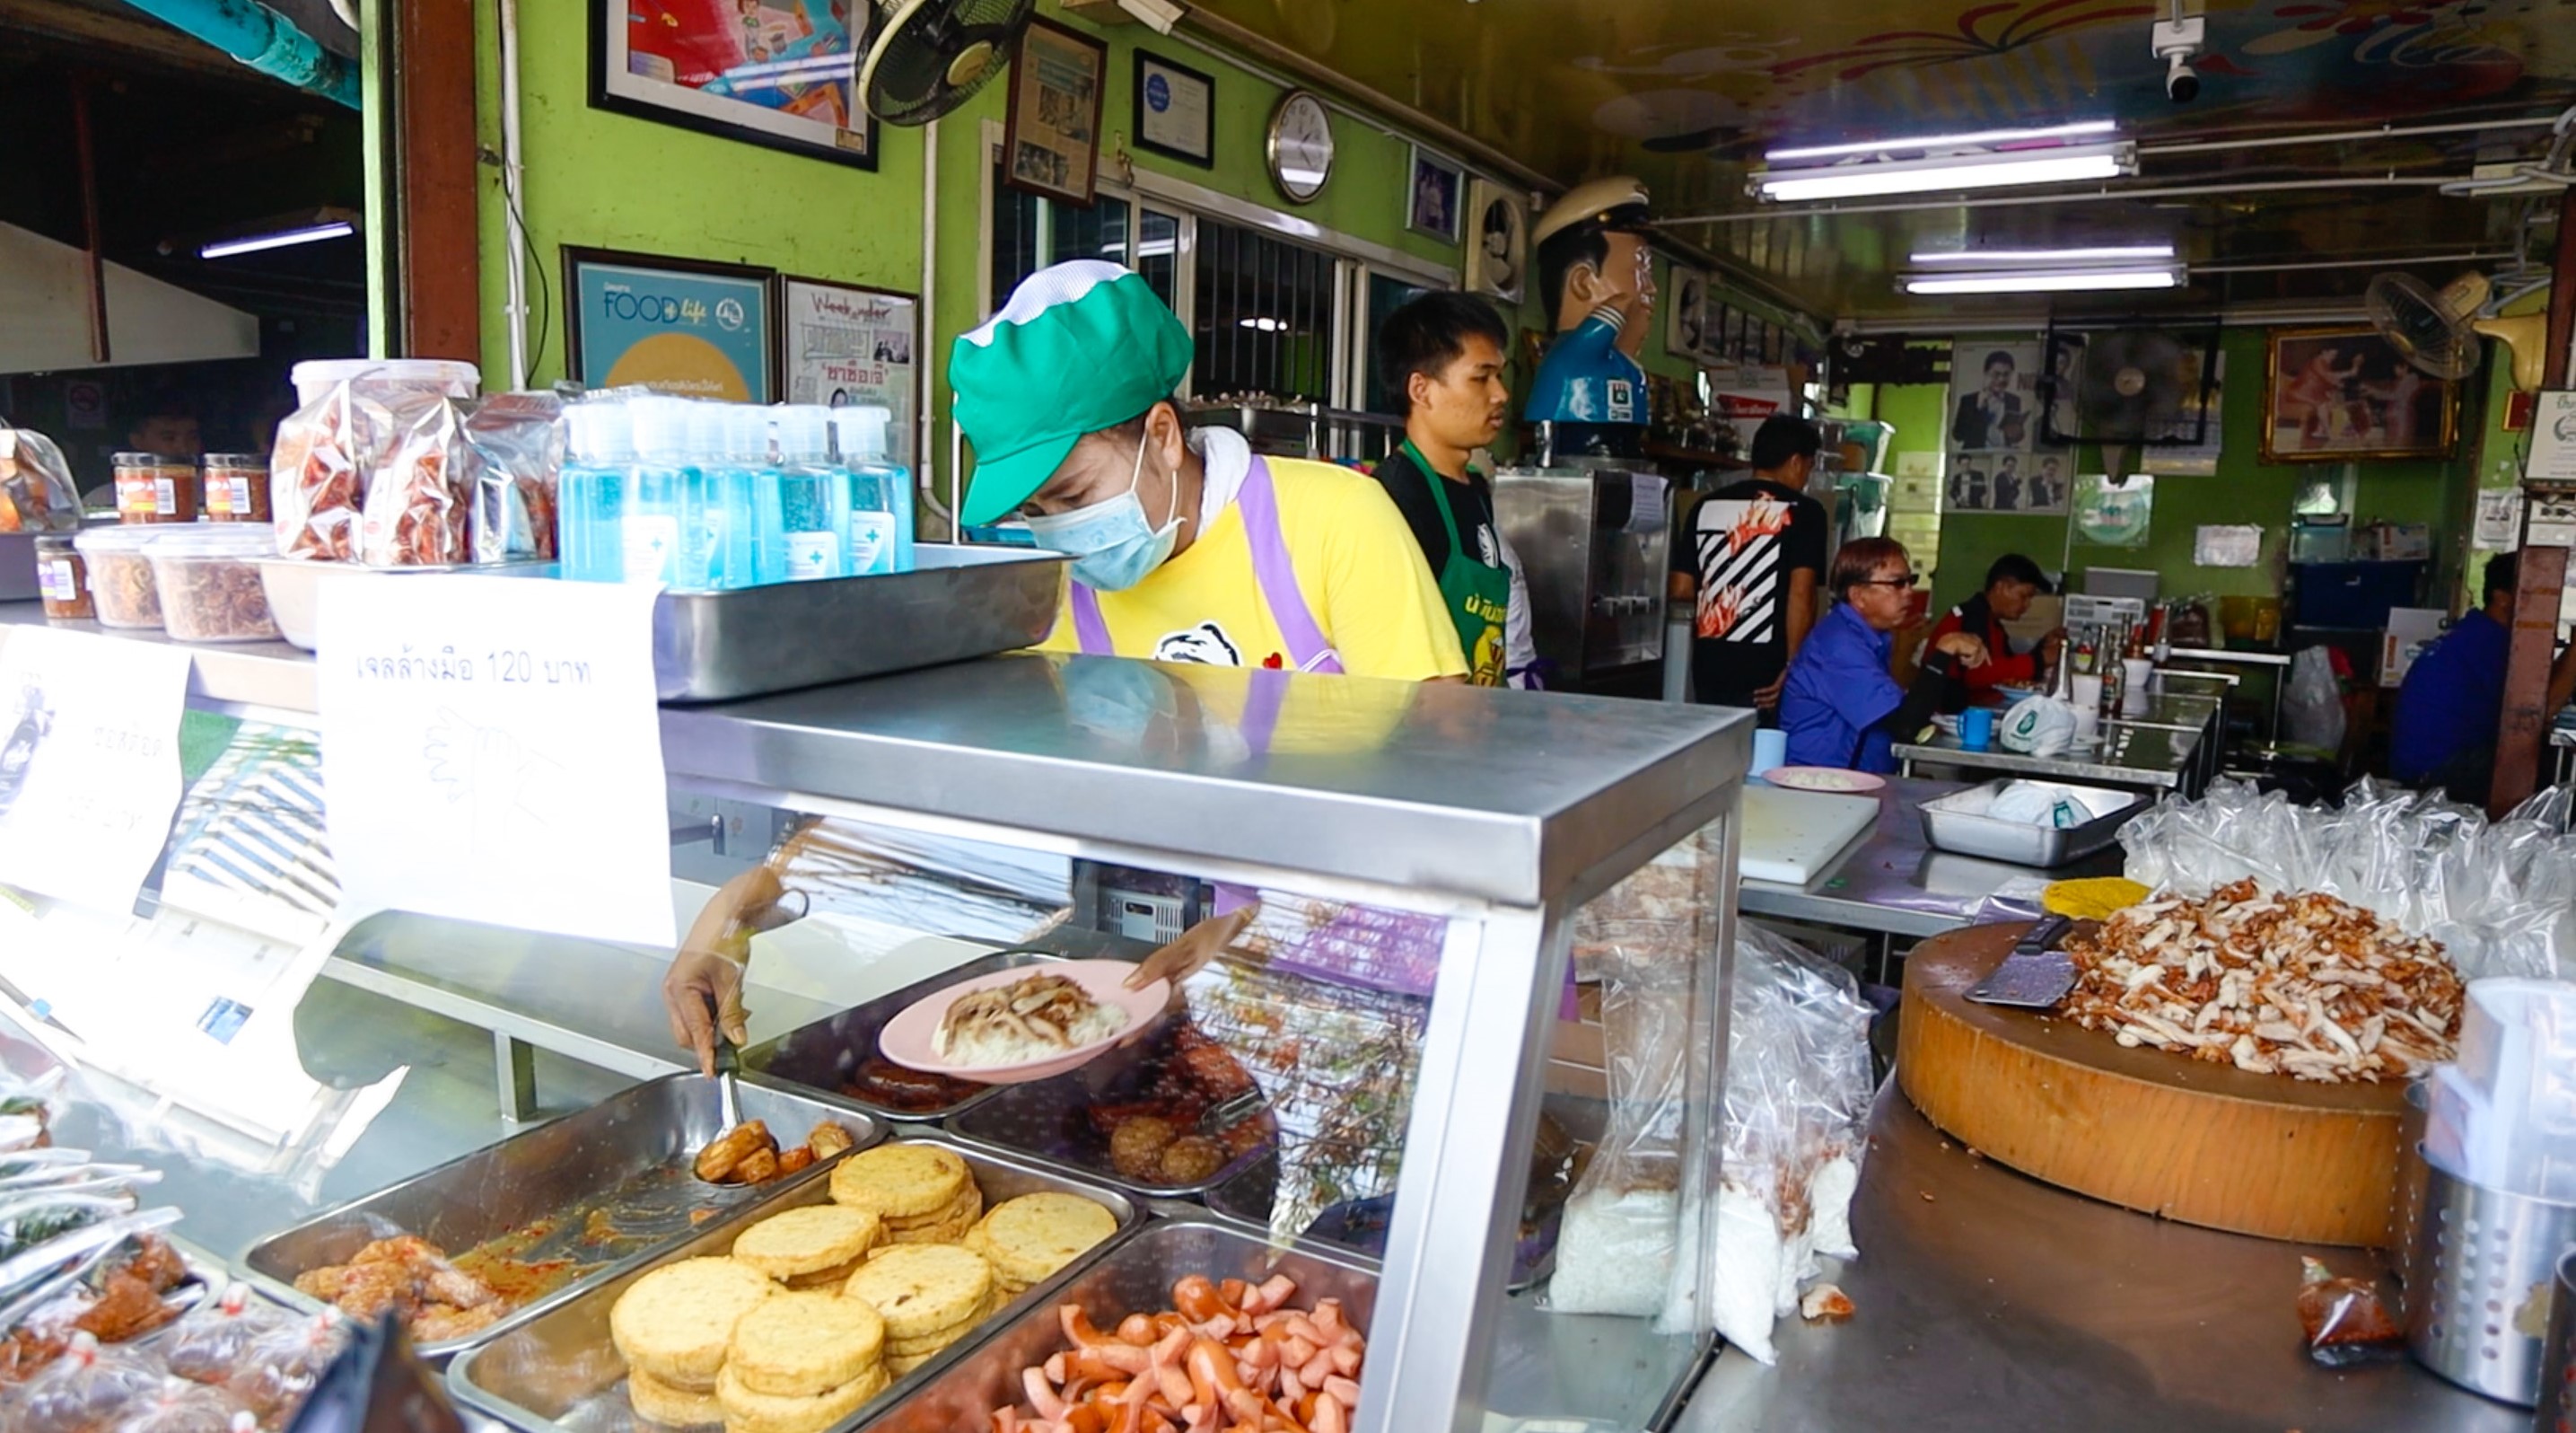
[565,245,773,402]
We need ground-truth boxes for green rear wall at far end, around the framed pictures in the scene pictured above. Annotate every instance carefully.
[1878,328,2488,620]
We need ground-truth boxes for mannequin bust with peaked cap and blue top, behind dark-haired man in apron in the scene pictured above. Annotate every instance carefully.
[1522,178,1654,456]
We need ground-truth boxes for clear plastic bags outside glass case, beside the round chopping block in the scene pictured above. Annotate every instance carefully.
[1661,926,1875,1363]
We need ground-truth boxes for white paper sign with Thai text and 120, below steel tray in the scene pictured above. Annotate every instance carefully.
[320,575,678,945]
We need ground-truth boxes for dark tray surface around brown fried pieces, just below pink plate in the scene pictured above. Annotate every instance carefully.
[948,1021,1273,1199]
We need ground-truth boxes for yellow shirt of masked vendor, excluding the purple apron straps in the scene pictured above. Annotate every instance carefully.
[1040,459,1502,681]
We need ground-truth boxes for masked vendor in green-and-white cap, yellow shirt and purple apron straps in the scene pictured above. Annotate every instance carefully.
[948,260,1466,681]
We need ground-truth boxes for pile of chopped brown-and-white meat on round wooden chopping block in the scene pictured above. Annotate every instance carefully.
[2061,882,2460,1083]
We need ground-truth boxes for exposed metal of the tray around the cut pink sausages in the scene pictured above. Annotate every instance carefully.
[861,1217,1378,1433]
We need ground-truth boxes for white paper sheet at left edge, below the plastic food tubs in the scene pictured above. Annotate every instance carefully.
[0,627,188,912]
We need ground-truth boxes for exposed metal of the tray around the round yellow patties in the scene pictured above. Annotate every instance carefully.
[448,1134,1143,1433]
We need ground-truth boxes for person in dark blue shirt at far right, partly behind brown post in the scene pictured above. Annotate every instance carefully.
[2388,551,2576,804]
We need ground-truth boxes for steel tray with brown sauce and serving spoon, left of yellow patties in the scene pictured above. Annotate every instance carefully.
[242,1075,883,1358]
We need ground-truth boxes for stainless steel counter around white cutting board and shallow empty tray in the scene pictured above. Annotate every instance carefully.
[1736,776,2120,938]
